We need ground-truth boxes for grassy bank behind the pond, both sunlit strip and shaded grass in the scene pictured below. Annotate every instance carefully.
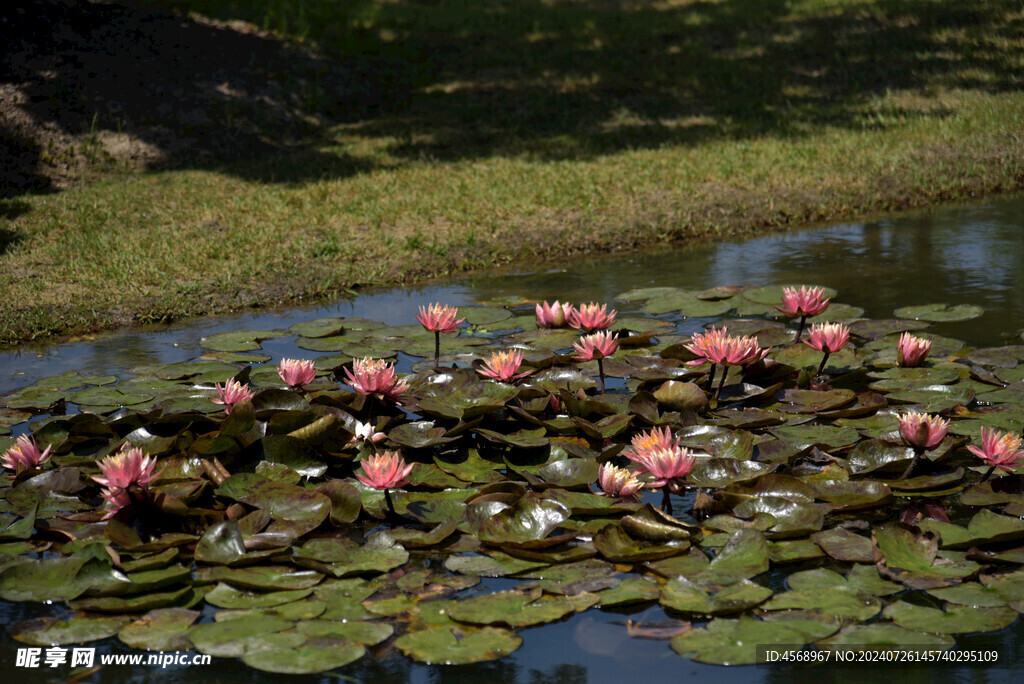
[0,0,1024,344]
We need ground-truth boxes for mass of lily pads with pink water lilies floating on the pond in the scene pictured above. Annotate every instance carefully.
[0,287,1024,673]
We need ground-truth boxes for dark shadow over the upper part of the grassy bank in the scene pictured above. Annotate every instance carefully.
[0,0,1024,191]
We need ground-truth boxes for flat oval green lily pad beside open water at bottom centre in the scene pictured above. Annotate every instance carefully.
[394,627,522,665]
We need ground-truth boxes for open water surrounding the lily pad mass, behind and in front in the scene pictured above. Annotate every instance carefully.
[0,198,1024,684]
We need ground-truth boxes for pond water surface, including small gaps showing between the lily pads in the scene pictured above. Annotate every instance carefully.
[0,194,1024,684]
